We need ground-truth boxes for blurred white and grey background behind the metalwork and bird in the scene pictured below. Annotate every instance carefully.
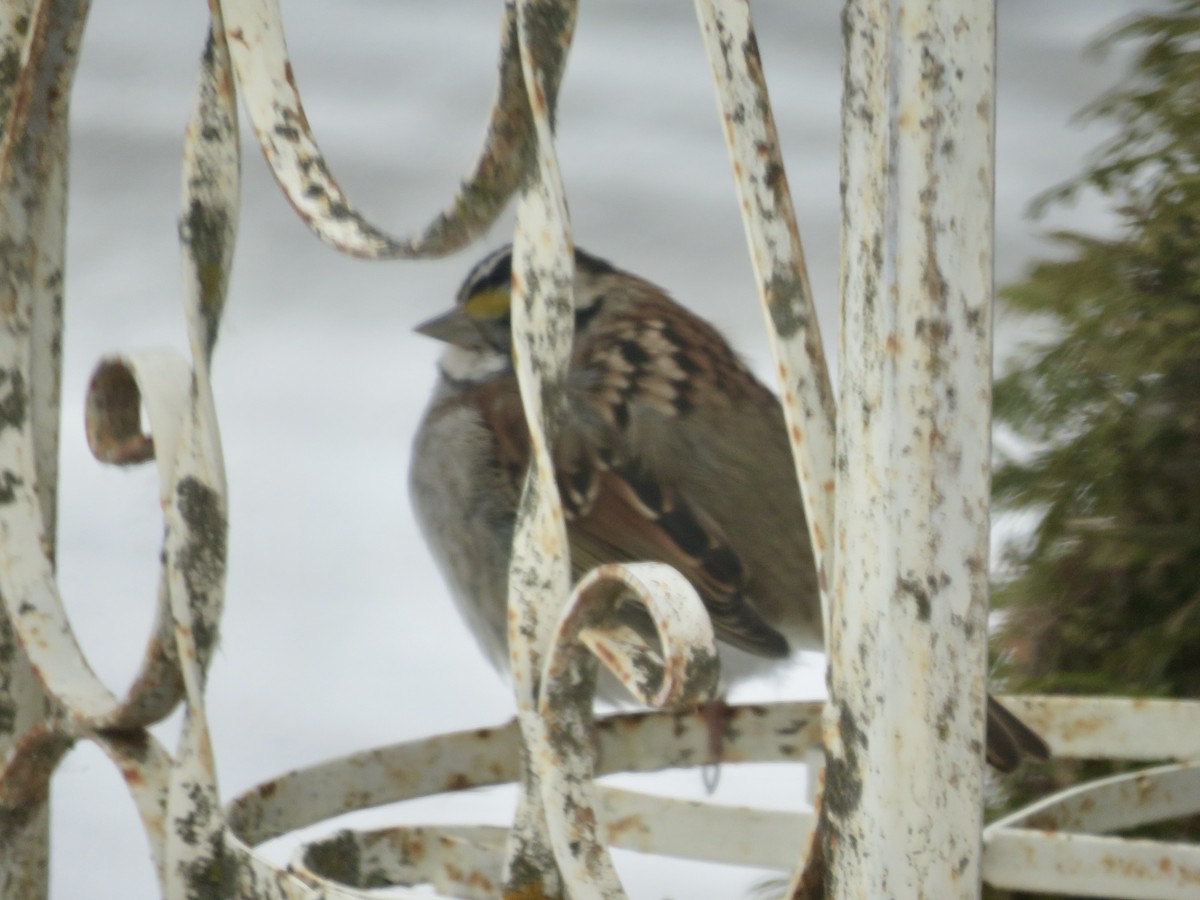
[44,0,1145,900]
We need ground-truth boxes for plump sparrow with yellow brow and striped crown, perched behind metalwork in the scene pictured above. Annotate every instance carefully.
[409,245,1048,770]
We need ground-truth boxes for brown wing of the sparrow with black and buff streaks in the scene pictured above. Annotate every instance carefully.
[476,290,790,658]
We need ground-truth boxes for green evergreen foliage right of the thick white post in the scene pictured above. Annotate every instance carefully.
[992,0,1200,897]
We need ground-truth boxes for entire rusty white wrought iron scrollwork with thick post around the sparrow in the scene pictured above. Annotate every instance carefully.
[0,0,1200,898]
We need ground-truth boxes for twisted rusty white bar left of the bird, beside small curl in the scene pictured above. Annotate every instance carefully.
[163,17,241,898]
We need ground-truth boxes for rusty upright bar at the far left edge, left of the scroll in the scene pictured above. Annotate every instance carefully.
[0,0,88,898]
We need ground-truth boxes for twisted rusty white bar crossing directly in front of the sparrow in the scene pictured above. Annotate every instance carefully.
[504,0,583,898]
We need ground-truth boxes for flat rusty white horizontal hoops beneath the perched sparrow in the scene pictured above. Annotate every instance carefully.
[220,697,1200,896]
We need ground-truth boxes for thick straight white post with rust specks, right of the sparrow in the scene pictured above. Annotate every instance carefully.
[826,0,995,898]
